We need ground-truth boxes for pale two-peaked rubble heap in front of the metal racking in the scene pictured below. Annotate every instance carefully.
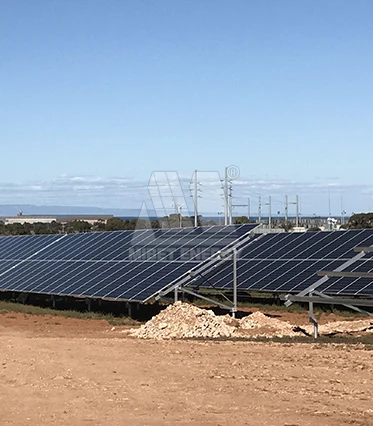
[130,302,299,339]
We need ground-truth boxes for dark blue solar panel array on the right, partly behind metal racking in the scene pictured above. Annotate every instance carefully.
[190,230,373,296]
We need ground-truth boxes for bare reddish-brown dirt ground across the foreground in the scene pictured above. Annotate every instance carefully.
[0,313,373,426]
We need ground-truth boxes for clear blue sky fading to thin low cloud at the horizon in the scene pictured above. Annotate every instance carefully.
[0,0,373,214]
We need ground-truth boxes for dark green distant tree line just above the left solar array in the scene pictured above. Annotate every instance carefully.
[0,214,216,235]
